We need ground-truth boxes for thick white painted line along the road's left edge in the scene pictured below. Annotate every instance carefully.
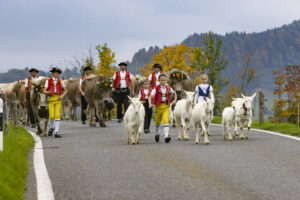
[28,131,54,200]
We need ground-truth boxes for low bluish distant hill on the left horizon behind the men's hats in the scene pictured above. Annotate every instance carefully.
[0,67,80,83]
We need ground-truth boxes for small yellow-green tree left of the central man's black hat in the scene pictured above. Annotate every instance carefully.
[96,43,116,78]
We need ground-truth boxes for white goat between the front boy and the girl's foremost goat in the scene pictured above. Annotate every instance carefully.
[173,92,195,140]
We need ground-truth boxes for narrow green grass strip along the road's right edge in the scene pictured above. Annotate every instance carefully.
[213,116,300,137]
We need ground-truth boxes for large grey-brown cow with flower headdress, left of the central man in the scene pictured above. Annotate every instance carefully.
[82,75,112,127]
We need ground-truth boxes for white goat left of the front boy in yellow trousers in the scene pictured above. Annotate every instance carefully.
[124,96,145,144]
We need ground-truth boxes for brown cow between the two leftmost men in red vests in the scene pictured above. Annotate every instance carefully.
[30,77,49,136]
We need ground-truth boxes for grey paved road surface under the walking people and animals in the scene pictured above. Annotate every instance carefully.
[26,121,300,200]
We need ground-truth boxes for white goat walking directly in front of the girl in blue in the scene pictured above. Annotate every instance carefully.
[192,98,214,144]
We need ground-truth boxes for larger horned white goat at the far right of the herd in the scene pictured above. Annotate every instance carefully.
[232,93,256,139]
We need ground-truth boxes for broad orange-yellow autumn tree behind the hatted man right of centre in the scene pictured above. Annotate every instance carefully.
[139,44,195,76]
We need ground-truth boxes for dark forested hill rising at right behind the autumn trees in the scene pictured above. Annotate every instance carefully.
[129,20,300,91]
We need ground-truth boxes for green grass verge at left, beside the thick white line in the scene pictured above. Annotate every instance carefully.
[0,124,34,200]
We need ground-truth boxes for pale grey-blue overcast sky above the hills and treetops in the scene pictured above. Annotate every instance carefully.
[0,0,300,72]
